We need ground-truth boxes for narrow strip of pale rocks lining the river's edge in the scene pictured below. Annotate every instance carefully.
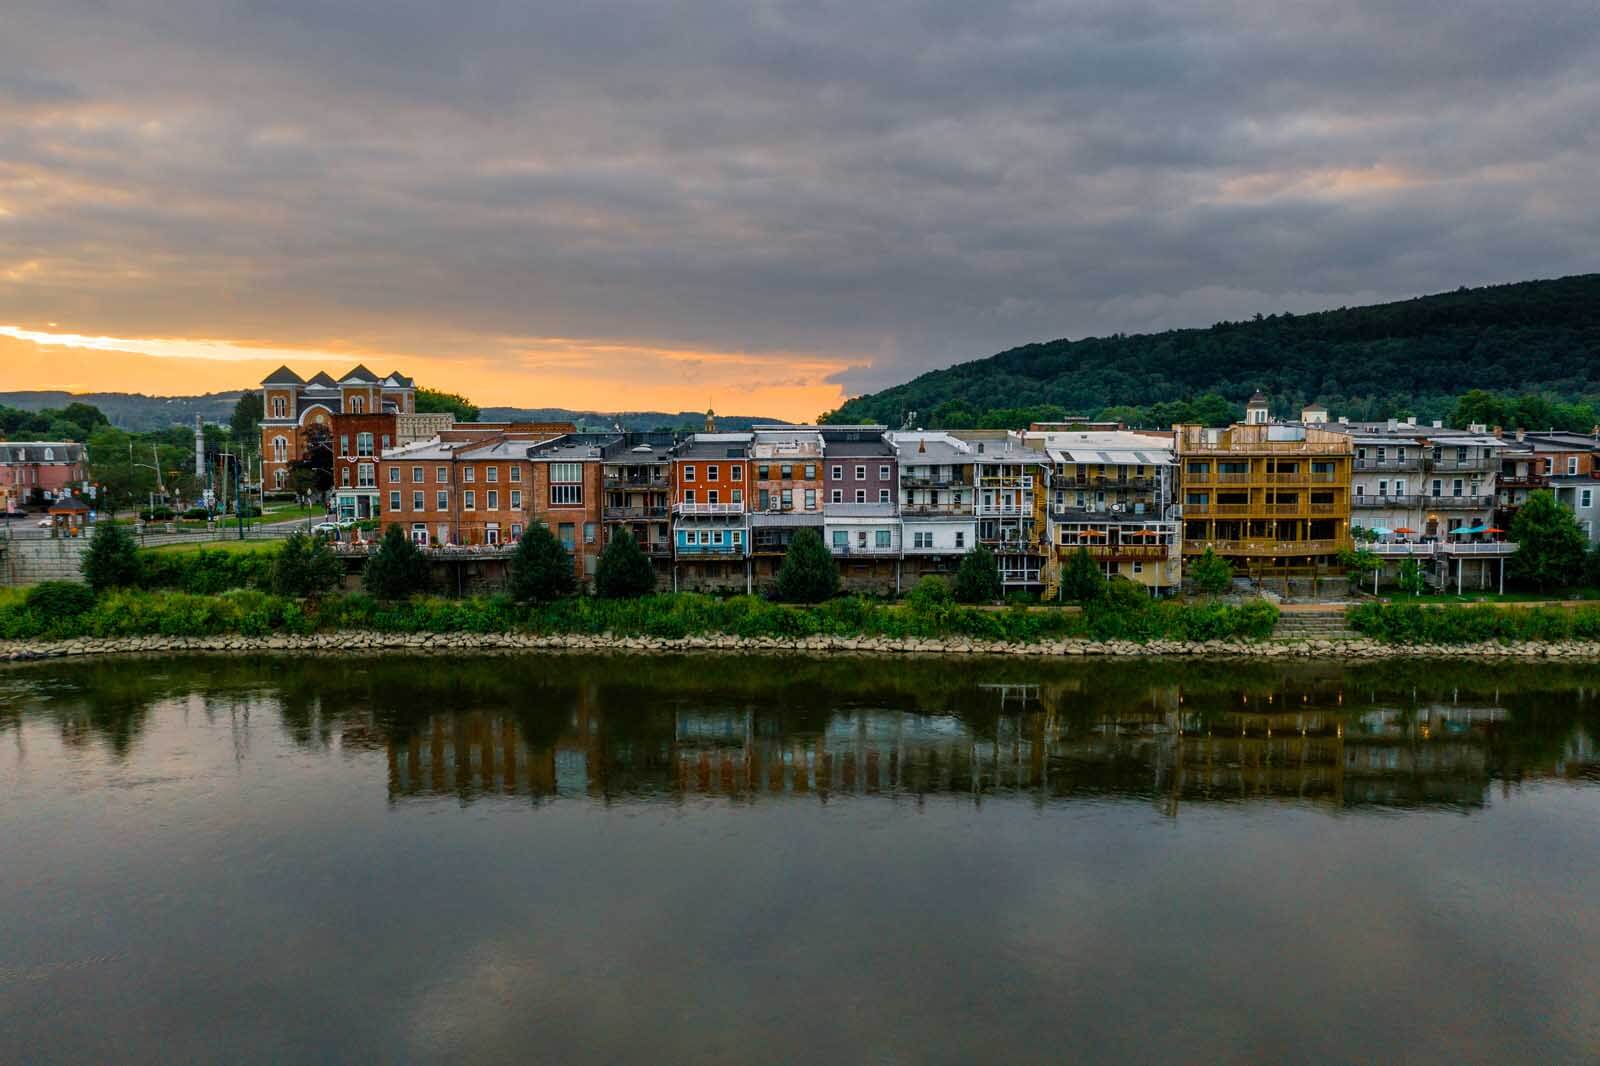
[0,631,1600,663]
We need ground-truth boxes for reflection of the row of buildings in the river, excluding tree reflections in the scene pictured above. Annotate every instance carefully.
[386,682,1600,815]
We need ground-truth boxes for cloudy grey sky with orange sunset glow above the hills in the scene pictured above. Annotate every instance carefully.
[0,0,1600,419]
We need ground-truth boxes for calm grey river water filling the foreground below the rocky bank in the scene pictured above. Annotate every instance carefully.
[0,658,1600,1064]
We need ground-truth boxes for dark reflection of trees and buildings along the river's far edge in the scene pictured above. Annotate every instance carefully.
[0,658,1600,816]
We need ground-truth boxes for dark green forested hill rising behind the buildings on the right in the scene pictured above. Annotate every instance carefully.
[827,274,1600,427]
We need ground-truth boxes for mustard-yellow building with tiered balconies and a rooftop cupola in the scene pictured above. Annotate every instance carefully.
[1173,405,1352,575]
